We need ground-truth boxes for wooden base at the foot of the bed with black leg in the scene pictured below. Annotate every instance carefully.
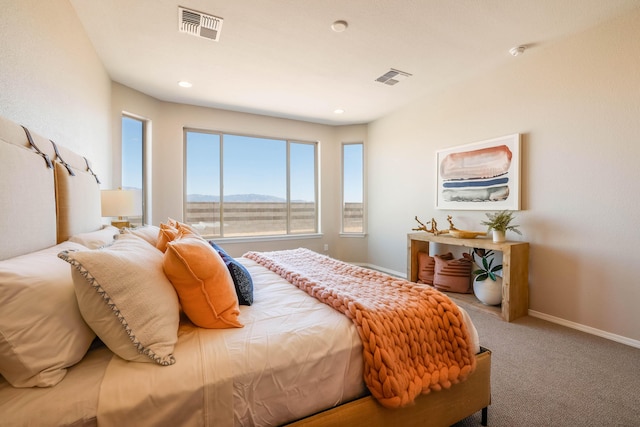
[289,348,491,427]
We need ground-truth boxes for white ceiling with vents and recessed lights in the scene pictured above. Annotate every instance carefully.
[70,0,640,124]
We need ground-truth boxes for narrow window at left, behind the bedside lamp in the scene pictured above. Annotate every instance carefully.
[121,115,145,227]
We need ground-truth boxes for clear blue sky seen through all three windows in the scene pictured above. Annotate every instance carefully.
[122,117,362,202]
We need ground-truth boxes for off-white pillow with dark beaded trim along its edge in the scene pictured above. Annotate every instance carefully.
[59,234,180,365]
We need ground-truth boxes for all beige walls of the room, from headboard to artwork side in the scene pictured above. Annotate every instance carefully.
[0,0,640,343]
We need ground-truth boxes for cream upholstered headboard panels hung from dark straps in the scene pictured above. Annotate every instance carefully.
[0,117,102,260]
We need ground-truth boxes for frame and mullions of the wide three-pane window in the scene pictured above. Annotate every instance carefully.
[182,127,321,242]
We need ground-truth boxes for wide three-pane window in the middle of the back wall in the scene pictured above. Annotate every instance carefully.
[184,129,318,237]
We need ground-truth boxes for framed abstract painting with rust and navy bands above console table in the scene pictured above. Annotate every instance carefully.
[436,134,520,210]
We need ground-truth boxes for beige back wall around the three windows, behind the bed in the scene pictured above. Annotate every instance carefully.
[112,83,366,262]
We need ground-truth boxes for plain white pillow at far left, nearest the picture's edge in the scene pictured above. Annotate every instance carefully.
[0,242,95,387]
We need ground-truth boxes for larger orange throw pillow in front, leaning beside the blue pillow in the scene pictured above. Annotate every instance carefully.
[162,233,242,329]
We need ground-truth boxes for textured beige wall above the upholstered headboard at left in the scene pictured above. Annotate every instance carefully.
[0,0,111,185]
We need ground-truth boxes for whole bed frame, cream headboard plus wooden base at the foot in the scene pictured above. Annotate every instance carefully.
[0,117,491,427]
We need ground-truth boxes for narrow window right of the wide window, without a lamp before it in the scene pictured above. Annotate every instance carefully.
[342,142,365,234]
